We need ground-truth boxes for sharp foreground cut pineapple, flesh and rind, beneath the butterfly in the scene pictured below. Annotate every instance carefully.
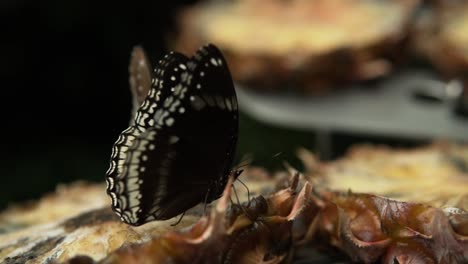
[0,144,468,263]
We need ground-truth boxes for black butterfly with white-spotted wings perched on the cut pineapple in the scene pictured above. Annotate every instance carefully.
[106,44,240,225]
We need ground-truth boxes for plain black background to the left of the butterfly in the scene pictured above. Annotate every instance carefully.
[0,0,195,208]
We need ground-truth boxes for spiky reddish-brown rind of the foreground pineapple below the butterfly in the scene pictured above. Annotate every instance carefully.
[94,164,468,263]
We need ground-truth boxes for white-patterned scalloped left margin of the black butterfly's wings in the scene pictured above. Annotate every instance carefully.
[106,52,188,224]
